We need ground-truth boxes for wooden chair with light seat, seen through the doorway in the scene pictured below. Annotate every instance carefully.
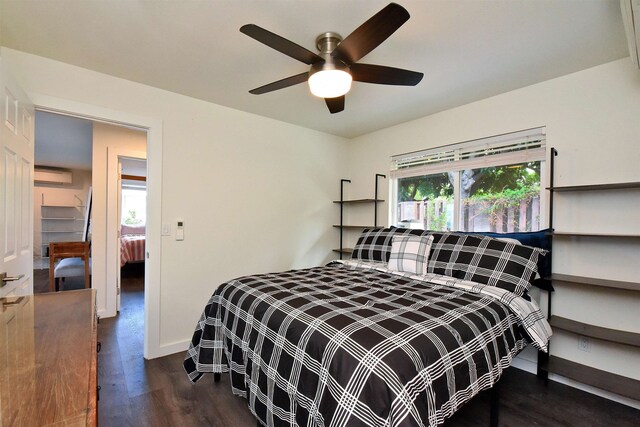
[49,242,91,292]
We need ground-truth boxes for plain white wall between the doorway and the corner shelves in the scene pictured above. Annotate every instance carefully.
[2,48,346,356]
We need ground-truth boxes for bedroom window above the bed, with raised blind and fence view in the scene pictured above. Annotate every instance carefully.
[391,128,545,232]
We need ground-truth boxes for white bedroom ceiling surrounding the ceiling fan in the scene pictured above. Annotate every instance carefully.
[0,0,628,138]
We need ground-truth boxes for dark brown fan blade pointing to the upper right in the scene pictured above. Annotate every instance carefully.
[331,3,410,64]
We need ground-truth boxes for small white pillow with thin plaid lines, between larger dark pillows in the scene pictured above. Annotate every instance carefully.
[388,236,433,275]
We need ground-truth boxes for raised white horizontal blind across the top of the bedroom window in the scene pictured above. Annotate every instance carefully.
[390,127,546,178]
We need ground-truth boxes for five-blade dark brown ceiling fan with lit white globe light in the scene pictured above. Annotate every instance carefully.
[240,3,423,114]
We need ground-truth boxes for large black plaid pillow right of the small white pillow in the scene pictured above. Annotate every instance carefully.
[427,233,546,296]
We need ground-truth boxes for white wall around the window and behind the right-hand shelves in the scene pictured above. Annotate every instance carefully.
[347,58,640,402]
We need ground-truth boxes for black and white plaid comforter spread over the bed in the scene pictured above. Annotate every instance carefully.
[184,262,550,427]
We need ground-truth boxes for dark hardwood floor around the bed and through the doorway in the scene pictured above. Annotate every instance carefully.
[35,271,640,427]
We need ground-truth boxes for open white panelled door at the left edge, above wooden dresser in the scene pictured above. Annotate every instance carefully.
[0,58,34,297]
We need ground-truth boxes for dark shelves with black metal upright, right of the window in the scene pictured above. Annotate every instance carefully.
[539,148,640,400]
